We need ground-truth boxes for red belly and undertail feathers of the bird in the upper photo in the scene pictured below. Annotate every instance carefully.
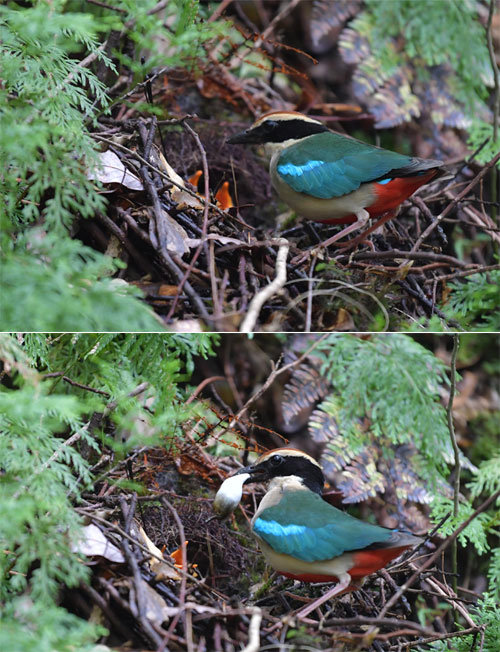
[318,170,438,224]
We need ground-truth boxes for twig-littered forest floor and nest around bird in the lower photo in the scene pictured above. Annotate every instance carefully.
[63,335,497,652]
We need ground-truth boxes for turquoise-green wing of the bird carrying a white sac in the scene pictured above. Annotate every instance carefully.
[253,490,393,561]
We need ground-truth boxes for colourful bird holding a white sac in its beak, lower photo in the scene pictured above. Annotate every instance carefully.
[214,447,422,619]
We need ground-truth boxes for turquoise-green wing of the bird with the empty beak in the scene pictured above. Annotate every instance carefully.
[276,132,419,199]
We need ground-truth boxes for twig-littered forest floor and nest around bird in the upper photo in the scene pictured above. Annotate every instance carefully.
[80,3,500,331]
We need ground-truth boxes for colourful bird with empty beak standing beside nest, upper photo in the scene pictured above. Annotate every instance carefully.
[227,111,443,247]
